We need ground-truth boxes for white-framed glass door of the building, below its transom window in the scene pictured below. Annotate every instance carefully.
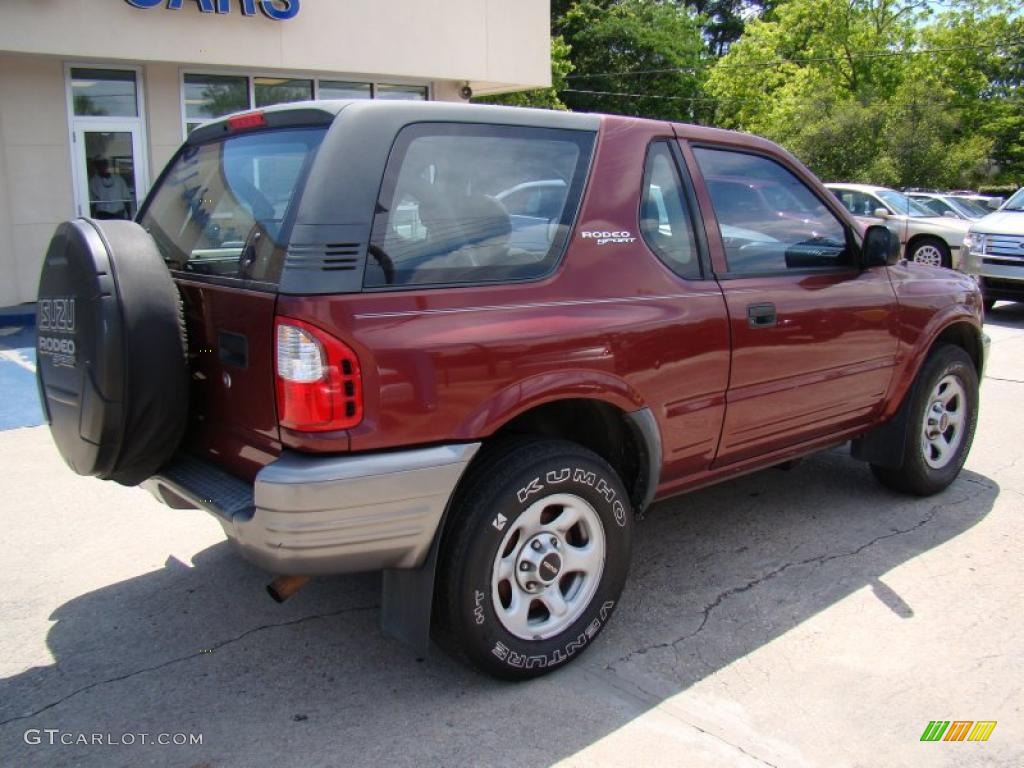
[73,120,147,219]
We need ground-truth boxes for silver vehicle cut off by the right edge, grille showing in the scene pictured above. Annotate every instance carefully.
[964,187,1024,309]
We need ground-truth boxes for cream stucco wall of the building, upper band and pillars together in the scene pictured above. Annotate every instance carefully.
[0,0,551,306]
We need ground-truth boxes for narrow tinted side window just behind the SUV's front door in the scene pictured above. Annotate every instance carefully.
[640,141,700,279]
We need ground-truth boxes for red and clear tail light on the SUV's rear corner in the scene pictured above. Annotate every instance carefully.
[276,317,362,432]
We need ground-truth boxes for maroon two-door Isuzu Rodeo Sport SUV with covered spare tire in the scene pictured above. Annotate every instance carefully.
[38,102,985,679]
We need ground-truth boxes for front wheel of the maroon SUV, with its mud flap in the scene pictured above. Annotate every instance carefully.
[871,345,978,496]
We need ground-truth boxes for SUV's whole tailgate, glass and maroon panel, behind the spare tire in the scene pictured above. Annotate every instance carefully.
[139,127,326,478]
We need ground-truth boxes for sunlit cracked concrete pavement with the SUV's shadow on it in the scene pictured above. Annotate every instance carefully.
[0,304,1024,768]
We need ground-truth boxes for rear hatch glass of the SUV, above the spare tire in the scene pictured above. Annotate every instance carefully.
[140,128,325,283]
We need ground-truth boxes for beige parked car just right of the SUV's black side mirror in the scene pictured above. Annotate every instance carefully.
[825,183,971,268]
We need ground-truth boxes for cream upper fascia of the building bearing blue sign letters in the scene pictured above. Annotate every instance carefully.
[0,0,551,92]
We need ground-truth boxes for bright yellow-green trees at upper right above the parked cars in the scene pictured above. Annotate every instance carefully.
[707,0,1024,186]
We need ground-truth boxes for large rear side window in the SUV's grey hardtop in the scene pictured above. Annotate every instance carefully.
[365,124,594,288]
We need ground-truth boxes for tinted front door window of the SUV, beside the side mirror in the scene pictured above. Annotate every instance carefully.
[694,147,853,273]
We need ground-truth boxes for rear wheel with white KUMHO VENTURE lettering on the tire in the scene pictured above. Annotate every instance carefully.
[434,439,633,680]
